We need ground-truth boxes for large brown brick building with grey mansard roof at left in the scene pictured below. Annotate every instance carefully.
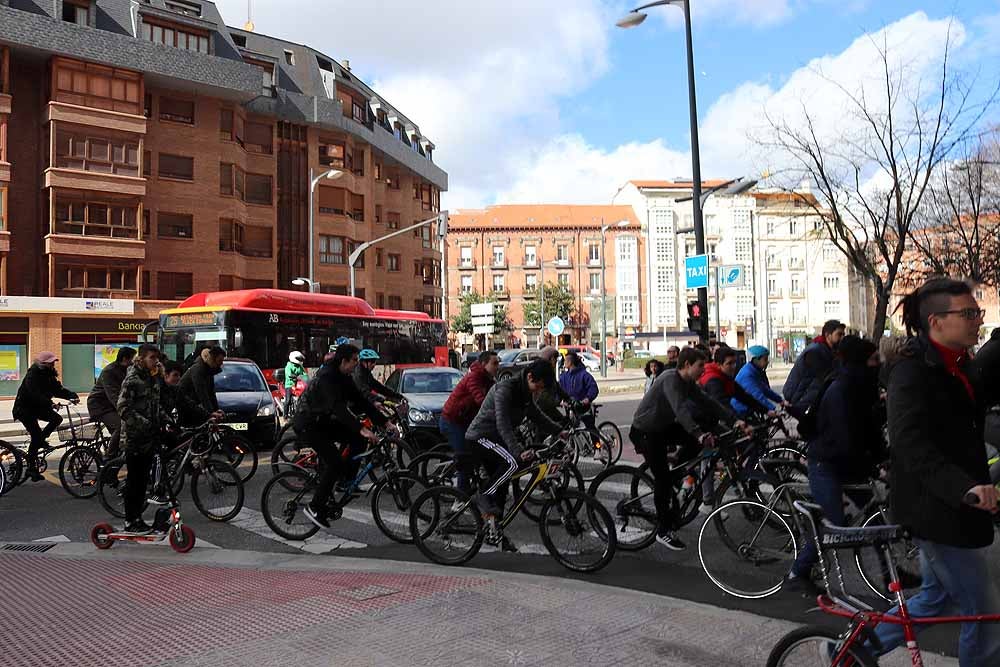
[0,0,447,393]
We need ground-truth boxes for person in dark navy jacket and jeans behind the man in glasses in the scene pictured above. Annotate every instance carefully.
[785,336,887,595]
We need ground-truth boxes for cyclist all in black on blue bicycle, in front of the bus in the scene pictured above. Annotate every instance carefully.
[294,343,387,528]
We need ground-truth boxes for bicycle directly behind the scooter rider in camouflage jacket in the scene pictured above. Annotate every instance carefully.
[97,420,245,522]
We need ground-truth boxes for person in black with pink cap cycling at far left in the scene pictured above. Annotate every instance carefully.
[13,352,80,482]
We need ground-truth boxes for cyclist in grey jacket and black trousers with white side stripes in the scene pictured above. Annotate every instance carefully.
[466,359,562,546]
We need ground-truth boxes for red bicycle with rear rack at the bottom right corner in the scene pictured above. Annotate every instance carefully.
[767,497,1000,667]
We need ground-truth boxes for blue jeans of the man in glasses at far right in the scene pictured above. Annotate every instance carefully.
[875,540,1000,667]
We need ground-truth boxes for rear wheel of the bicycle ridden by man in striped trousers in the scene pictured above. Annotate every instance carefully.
[410,486,484,565]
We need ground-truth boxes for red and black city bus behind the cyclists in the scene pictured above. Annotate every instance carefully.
[157,289,448,382]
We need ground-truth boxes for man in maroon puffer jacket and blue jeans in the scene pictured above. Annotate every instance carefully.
[438,350,500,493]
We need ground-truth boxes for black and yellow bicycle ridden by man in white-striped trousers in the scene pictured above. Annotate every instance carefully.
[410,437,617,572]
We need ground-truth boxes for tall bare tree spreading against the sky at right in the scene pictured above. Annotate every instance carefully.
[758,26,996,340]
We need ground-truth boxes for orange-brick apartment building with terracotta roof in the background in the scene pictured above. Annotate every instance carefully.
[446,205,649,349]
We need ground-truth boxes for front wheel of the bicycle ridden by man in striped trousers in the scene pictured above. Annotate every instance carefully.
[538,490,617,572]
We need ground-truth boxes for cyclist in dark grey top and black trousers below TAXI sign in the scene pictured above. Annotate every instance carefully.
[629,347,745,551]
